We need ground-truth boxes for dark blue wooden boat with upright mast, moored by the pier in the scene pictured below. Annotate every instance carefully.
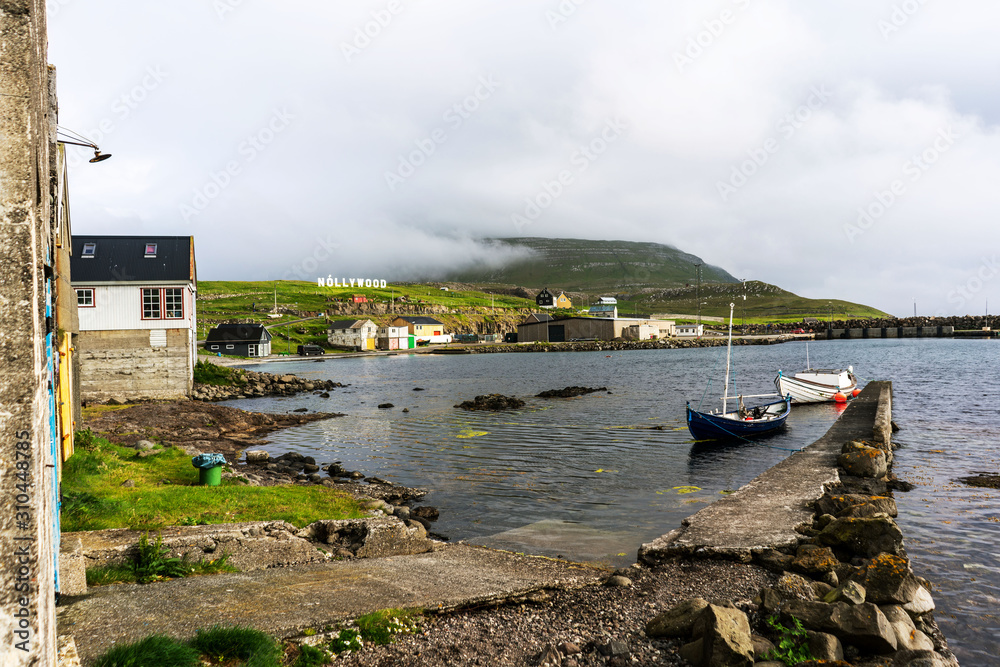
[687,303,792,440]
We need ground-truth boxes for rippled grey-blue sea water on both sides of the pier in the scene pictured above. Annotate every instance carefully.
[230,339,1000,664]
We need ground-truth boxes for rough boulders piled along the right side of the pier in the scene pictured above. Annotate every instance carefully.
[640,383,958,667]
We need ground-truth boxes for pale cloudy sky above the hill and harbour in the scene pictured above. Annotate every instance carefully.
[48,0,1000,316]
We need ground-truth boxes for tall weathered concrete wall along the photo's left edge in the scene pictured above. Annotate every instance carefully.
[0,0,56,667]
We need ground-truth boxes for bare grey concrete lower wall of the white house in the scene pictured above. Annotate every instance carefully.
[77,329,194,402]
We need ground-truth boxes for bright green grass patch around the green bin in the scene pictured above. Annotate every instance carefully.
[61,436,364,532]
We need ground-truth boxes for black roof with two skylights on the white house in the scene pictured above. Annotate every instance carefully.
[70,236,197,284]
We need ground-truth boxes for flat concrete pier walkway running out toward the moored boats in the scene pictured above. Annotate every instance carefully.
[639,382,892,564]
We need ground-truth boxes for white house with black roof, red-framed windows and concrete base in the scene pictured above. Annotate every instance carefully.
[70,235,198,401]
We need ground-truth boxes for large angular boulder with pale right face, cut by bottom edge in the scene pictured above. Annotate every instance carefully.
[682,604,753,667]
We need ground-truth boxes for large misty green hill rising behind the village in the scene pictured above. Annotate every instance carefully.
[444,238,738,293]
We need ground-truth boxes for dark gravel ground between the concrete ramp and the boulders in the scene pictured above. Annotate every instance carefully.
[334,561,775,667]
